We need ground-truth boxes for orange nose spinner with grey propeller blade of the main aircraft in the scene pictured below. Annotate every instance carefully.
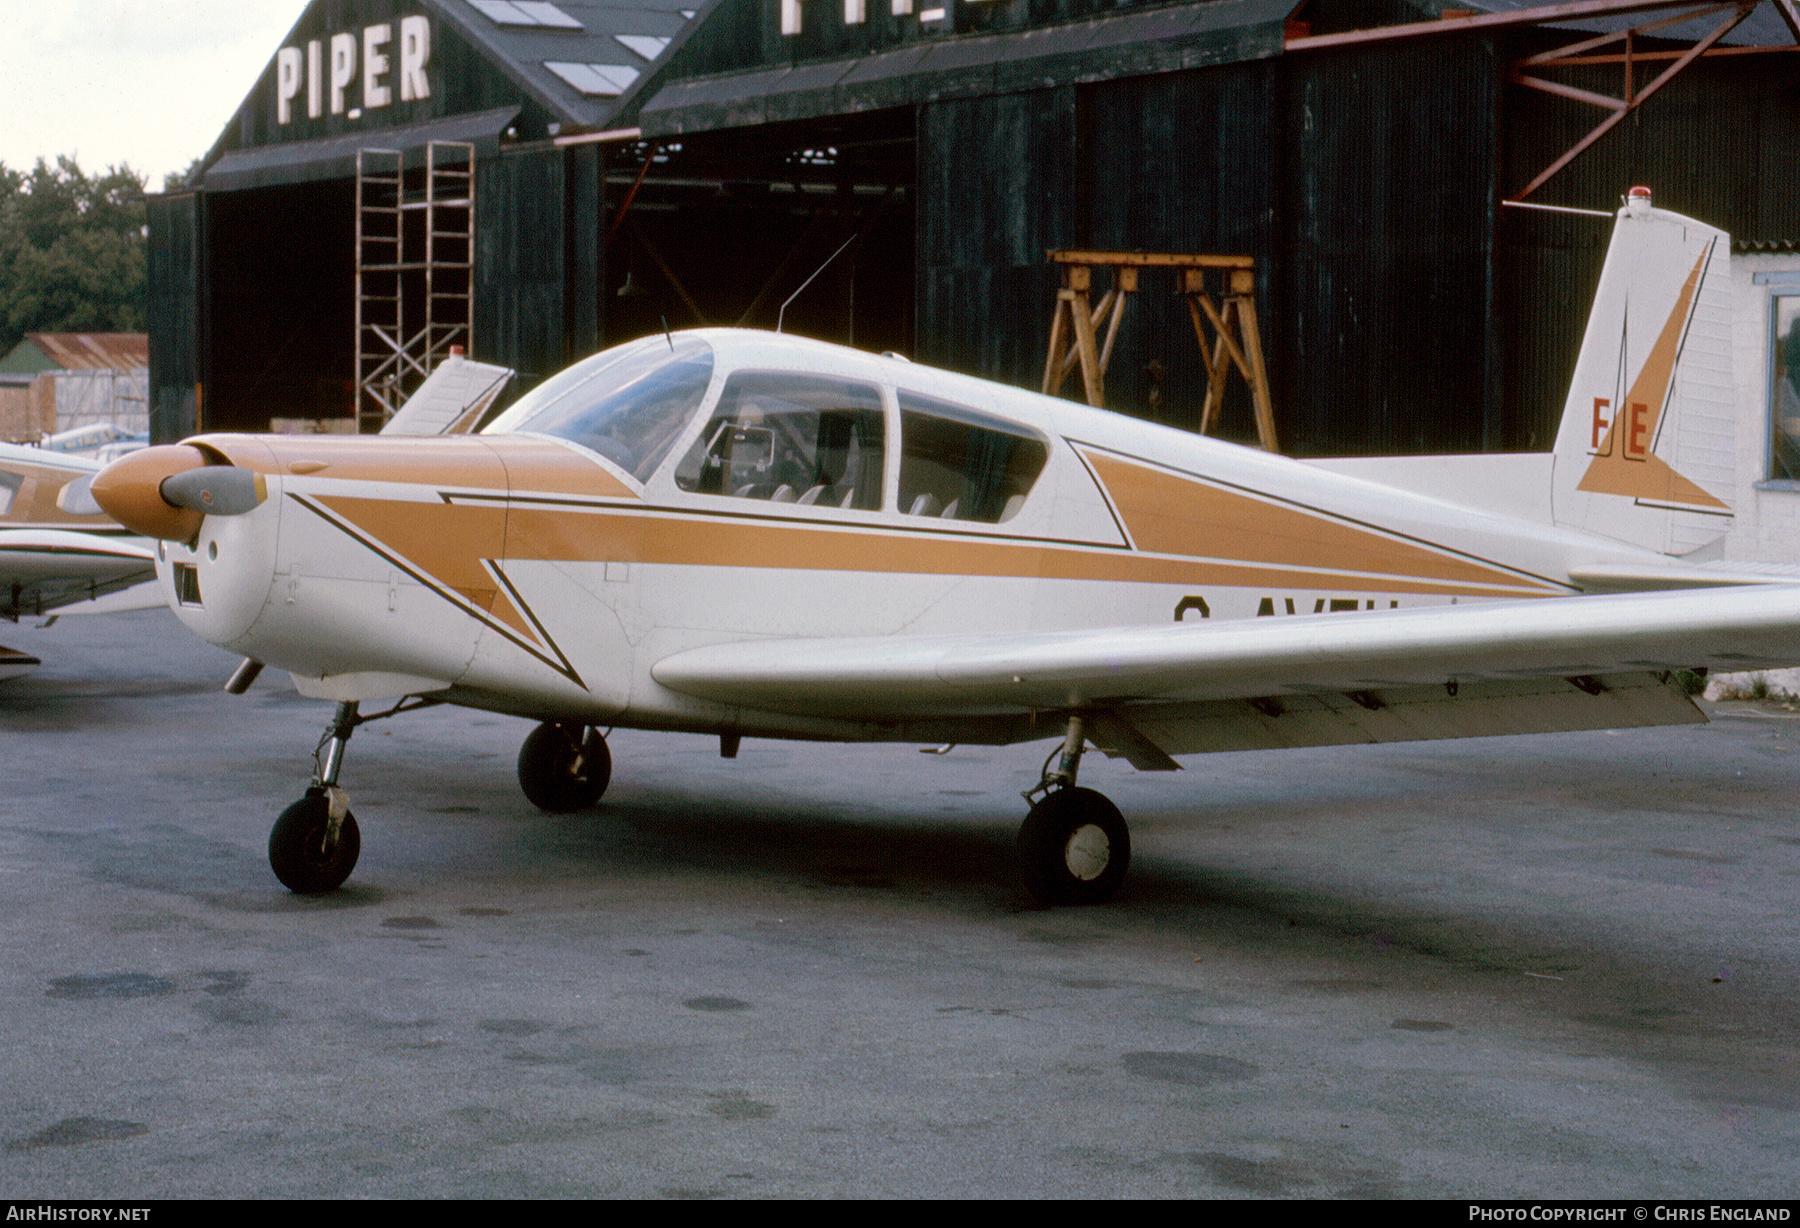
[88,443,255,542]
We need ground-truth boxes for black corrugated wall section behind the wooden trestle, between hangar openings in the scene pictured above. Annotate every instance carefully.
[918,43,1503,456]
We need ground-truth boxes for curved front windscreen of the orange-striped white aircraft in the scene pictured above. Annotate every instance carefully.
[482,337,713,481]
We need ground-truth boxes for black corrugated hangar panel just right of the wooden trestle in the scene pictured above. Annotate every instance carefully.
[1271,41,1503,456]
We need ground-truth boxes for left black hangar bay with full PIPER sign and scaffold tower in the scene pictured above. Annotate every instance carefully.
[149,0,698,439]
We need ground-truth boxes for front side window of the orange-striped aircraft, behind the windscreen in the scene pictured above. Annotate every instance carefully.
[675,371,884,511]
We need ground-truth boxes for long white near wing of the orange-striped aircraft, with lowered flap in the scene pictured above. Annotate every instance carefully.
[652,585,1800,767]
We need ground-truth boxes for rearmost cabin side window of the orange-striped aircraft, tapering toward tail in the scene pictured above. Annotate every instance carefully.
[900,391,1049,524]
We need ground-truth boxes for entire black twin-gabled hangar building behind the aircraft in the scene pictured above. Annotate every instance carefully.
[151,0,1800,477]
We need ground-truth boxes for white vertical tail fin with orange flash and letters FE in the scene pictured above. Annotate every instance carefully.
[1553,187,1735,555]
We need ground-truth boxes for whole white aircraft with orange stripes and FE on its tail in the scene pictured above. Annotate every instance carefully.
[94,194,1800,902]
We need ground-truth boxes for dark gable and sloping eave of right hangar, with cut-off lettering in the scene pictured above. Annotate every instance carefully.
[616,0,1795,137]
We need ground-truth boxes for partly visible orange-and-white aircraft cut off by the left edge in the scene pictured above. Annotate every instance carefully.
[0,443,162,681]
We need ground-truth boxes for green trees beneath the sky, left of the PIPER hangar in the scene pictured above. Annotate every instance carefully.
[0,157,148,353]
